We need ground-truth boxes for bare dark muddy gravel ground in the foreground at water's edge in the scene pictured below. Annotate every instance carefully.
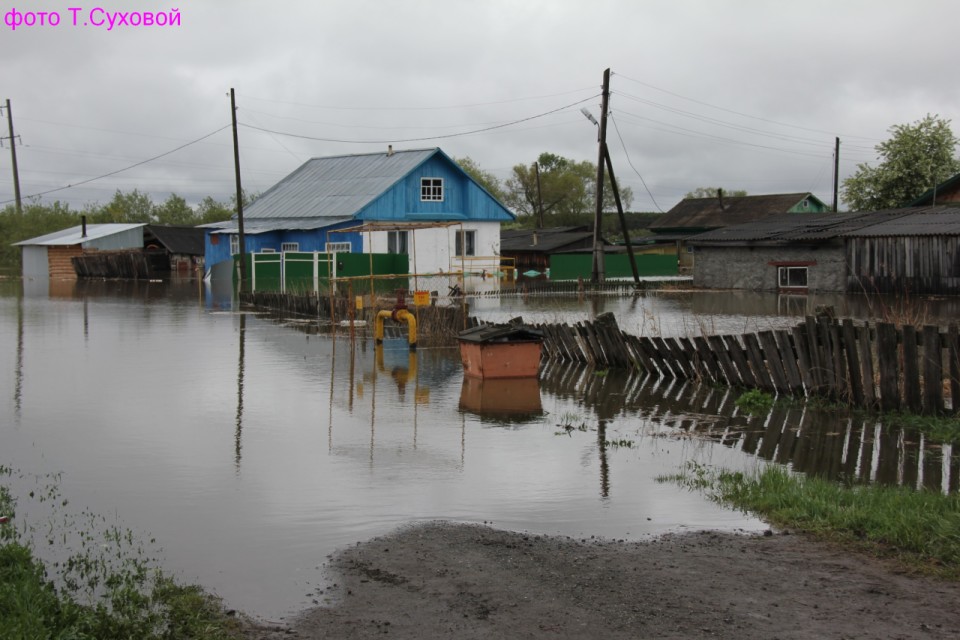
[249,522,960,640]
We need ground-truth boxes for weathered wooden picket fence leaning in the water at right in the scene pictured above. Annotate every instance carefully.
[538,314,960,414]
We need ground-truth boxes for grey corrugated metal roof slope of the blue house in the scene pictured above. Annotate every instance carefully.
[243,148,440,221]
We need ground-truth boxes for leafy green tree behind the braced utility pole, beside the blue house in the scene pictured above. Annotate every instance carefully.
[505,153,633,225]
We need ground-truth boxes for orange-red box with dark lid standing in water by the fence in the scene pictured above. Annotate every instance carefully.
[459,322,543,378]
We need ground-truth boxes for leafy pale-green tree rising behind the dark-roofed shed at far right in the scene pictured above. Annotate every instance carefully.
[843,115,960,211]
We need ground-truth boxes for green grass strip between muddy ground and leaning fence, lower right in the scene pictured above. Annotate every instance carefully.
[659,465,960,580]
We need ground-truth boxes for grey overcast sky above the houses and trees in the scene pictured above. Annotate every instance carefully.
[0,0,960,211]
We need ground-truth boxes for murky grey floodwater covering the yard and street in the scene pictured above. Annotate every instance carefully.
[0,282,958,618]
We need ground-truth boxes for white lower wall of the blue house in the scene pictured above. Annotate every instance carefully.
[363,222,500,273]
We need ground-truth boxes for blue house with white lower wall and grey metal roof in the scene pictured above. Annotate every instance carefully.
[205,147,514,278]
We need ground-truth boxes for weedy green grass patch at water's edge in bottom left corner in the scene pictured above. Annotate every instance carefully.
[0,467,243,640]
